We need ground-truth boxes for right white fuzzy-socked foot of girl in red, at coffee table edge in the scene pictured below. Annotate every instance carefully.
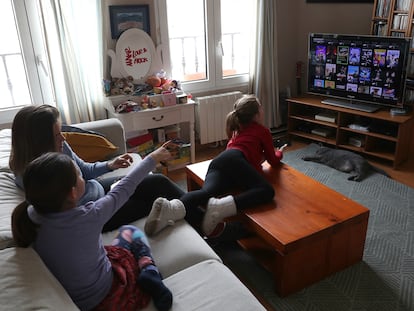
[201,195,237,236]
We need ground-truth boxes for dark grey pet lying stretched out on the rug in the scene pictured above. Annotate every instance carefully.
[302,146,389,181]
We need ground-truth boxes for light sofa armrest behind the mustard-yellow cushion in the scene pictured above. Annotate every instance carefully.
[72,118,127,154]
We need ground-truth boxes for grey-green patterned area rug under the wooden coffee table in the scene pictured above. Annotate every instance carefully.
[216,144,414,311]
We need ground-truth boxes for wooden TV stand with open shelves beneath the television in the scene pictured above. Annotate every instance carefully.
[287,95,414,168]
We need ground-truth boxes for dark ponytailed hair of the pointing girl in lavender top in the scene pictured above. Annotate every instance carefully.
[12,152,77,247]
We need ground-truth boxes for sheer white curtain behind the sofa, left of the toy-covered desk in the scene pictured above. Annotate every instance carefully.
[40,0,105,124]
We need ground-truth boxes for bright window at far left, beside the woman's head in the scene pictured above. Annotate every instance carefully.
[0,0,53,124]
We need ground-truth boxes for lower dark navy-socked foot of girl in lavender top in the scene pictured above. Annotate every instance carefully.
[137,269,173,311]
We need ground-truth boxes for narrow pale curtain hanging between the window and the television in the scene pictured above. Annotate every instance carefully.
[249,0,282,128]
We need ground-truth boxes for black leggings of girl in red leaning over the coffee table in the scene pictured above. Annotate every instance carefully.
[181,149,275,223]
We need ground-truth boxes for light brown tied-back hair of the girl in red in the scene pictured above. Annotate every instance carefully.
[226,95,260,139]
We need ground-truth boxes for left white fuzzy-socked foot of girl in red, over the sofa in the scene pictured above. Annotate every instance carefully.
[144,198,186,236]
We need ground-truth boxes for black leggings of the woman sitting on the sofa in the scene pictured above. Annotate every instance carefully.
[102,174,185,232]
